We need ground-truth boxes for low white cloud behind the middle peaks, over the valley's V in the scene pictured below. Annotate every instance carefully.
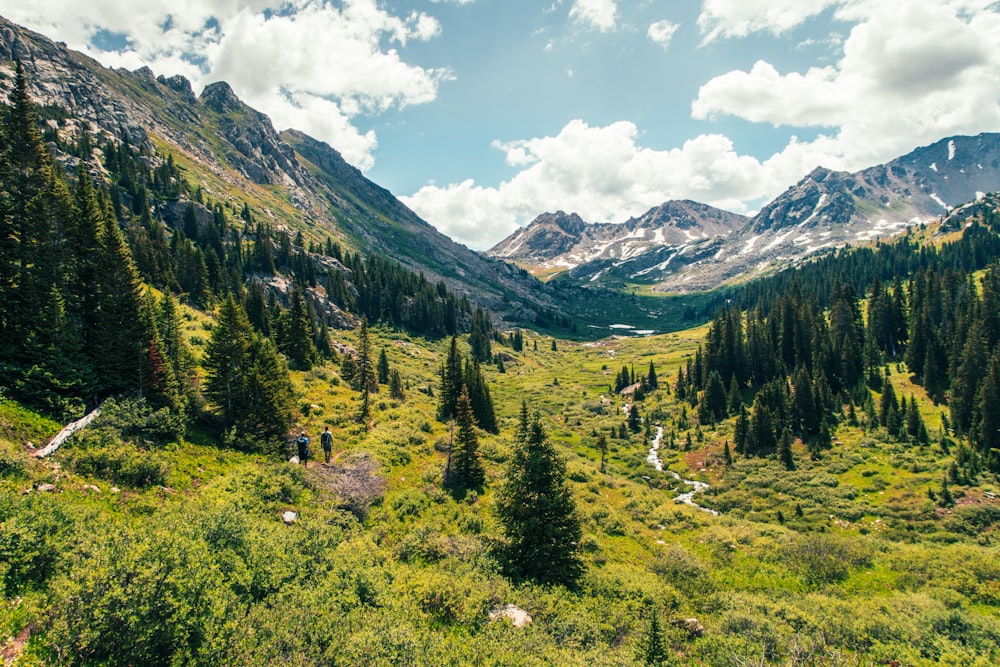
[403,120,787,249]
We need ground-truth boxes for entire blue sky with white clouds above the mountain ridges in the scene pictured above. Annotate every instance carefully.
[0,0,1000,249]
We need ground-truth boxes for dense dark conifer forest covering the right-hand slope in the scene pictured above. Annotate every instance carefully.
[677,219,1000,472]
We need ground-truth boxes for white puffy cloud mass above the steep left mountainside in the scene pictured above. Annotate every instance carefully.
[4,0,446,168]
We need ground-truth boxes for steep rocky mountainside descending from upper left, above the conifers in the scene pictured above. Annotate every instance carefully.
[0,18,559,326]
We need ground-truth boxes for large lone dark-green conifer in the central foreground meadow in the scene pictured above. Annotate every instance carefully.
[495,403,584,585]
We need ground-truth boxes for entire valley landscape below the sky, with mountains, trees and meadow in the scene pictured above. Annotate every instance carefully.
[0,10,1000,667]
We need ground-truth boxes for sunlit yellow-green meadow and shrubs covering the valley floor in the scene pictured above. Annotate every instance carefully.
[0,320,1000,666]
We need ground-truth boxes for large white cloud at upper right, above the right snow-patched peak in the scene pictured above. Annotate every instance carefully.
[692,0,1000,169]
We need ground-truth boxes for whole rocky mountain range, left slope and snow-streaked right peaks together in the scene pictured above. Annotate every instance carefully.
[0,11,1000,312]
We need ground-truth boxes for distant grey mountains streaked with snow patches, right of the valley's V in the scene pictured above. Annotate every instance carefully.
[489,134,1000,292]
